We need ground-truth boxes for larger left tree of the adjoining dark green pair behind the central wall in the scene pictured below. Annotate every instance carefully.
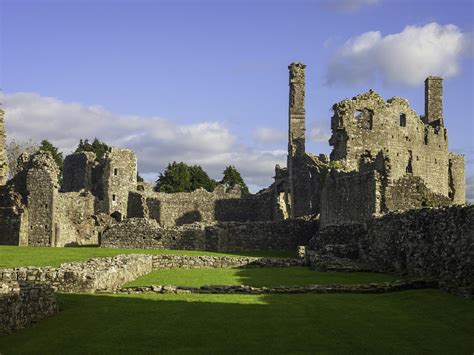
[155,161,191,193]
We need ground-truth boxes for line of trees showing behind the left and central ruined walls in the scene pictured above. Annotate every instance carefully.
[7,138,249,194]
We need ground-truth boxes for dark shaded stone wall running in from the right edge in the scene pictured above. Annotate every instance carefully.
[310,205,474,297]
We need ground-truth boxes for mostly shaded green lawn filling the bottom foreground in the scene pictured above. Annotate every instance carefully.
[0,290,474,355]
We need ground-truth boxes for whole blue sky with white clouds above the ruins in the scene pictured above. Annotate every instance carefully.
[0,0,474,198]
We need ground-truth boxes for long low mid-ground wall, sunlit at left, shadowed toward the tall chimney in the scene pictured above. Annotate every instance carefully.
[100,218,318,252]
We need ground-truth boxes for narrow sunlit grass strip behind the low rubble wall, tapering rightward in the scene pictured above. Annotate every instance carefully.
[0,246,295,268]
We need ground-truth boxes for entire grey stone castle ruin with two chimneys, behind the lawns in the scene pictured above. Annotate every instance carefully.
[0,63,465,250]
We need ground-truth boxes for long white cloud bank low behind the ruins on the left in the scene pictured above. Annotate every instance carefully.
[0,93,286,192]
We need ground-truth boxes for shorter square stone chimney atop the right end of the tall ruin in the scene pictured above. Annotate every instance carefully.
[425,76,444,127]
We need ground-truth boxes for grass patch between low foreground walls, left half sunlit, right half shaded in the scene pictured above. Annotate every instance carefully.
[125,267,400,287]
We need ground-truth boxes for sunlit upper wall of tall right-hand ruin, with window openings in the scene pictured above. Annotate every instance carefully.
[330,90,449,196]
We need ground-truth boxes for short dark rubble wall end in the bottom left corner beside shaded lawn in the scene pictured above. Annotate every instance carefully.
[0,281,58,336]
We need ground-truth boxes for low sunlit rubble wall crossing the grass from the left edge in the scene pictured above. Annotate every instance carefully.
[0,254,152,292]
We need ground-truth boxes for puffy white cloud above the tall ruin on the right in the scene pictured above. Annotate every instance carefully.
[326,23,473,86]
